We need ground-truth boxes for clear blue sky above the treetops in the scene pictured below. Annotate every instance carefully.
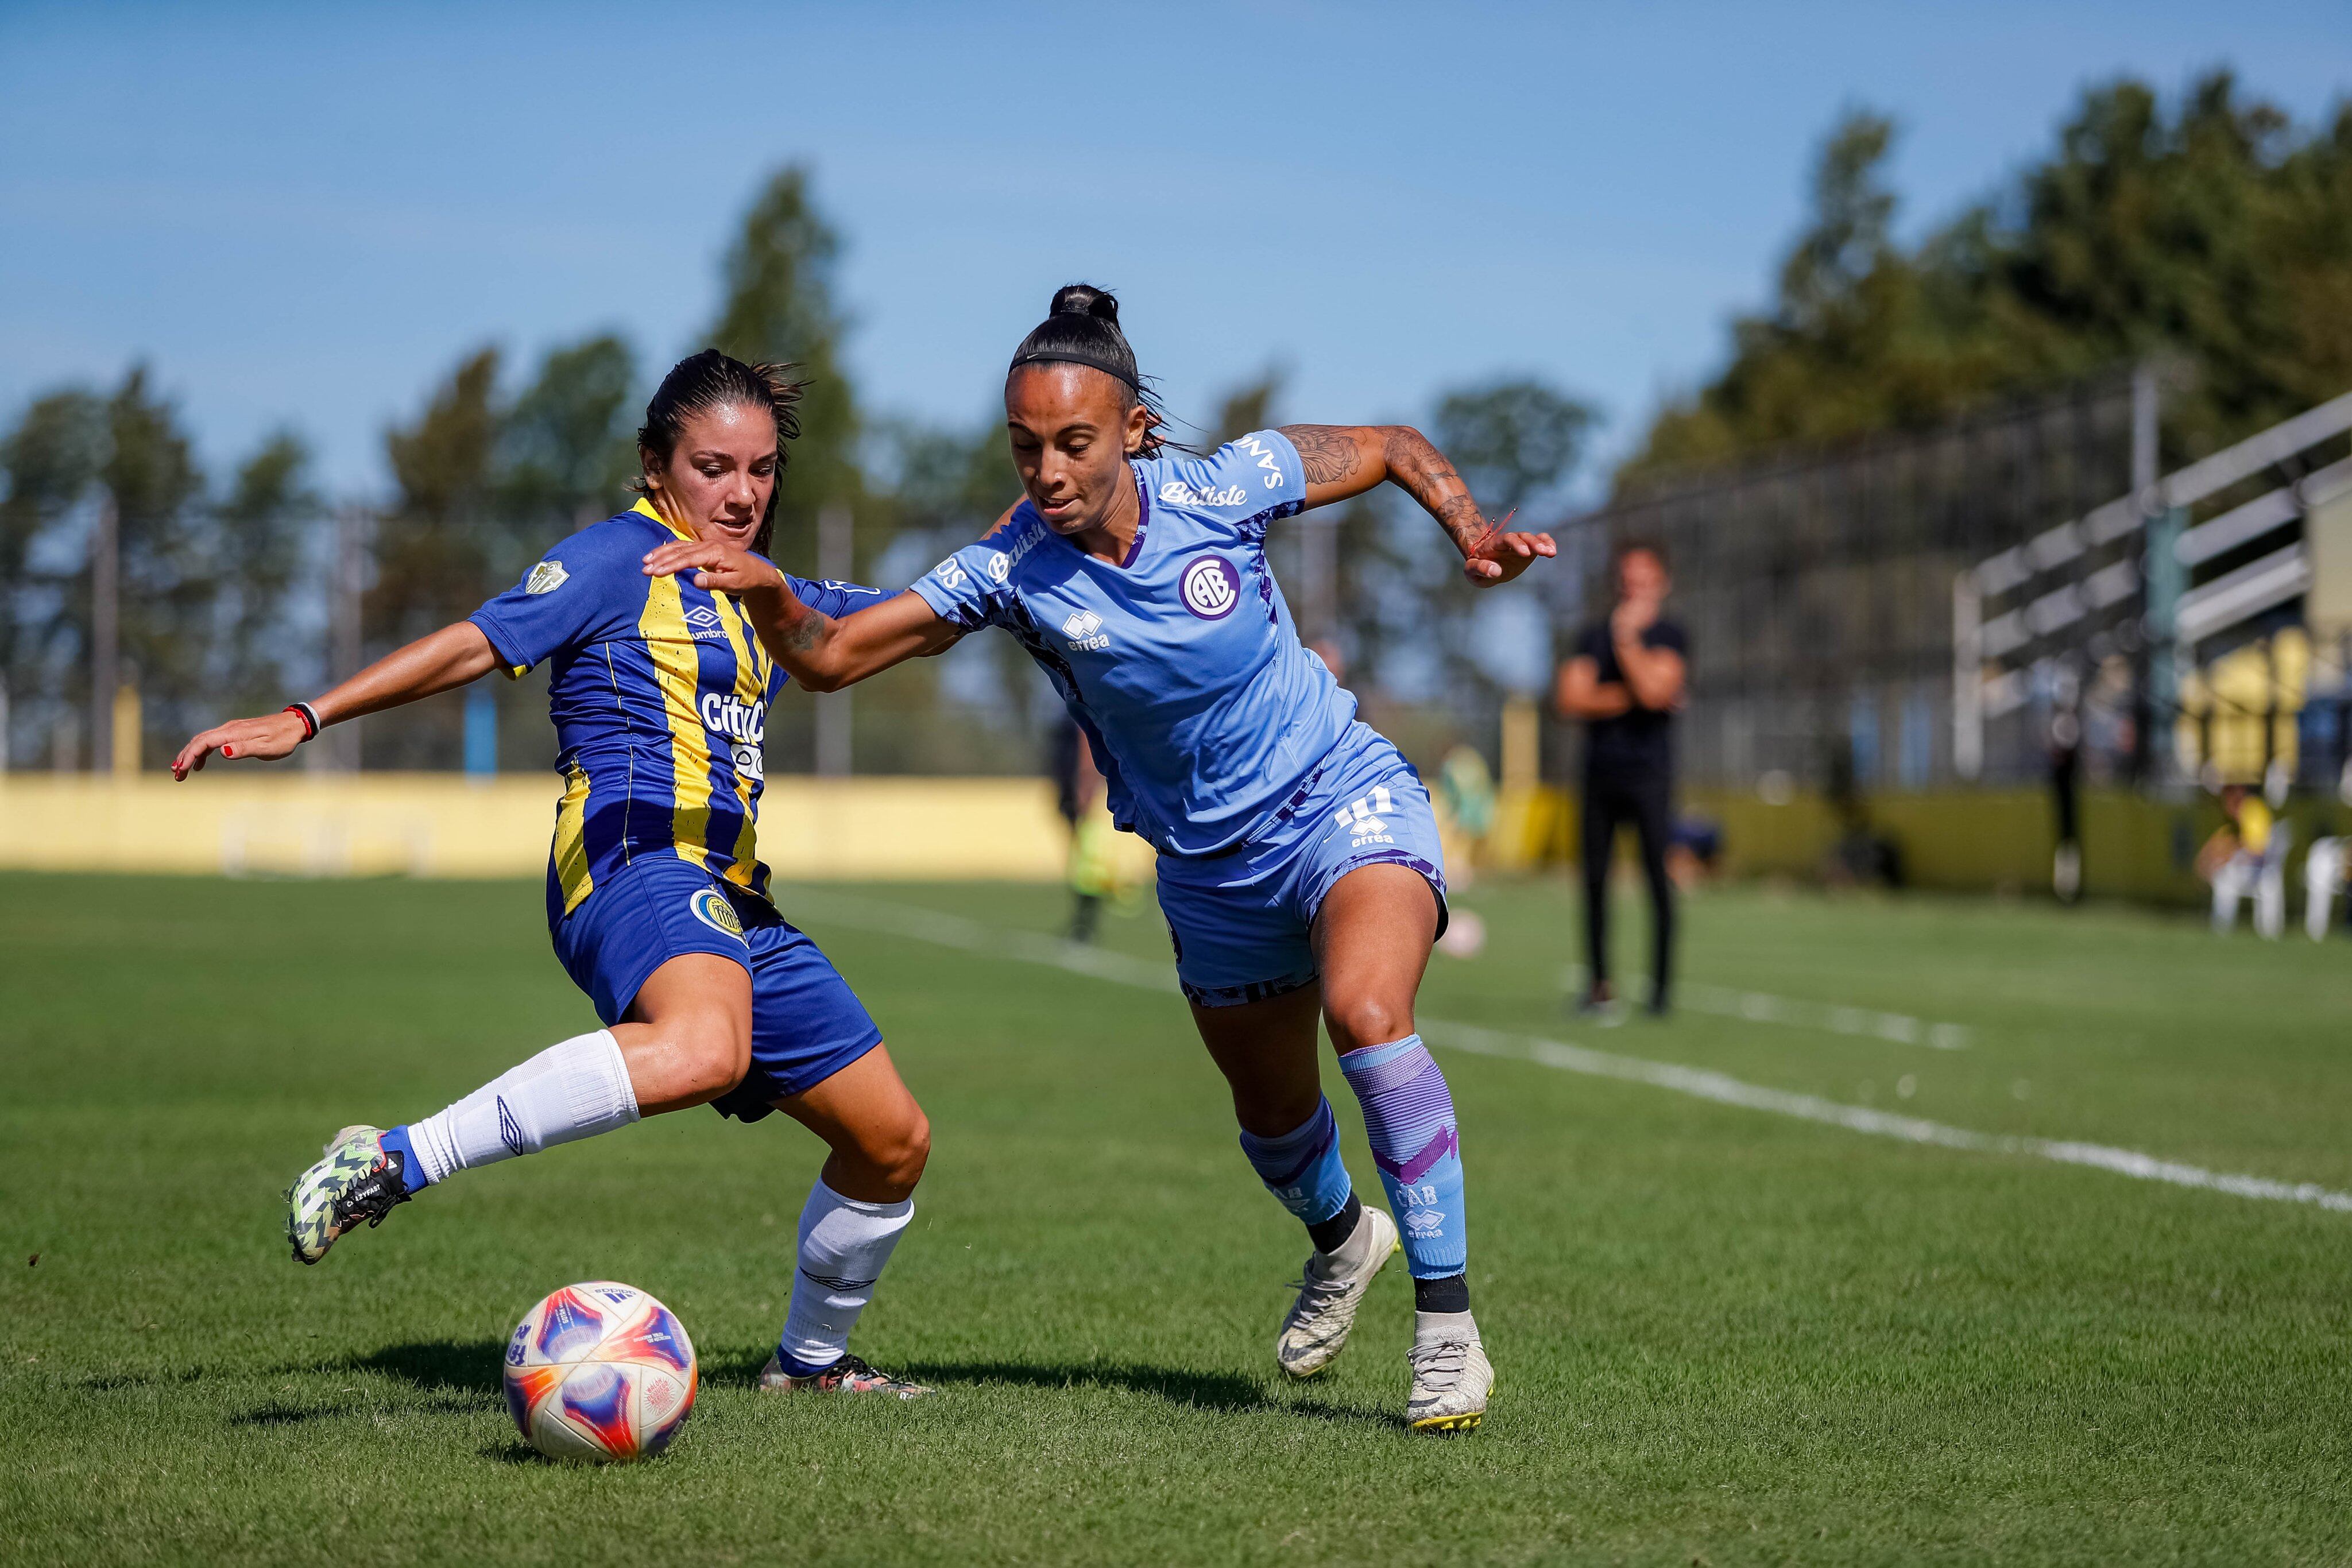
[0,0,2352,494]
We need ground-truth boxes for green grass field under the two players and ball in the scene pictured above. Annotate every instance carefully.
[0,877,2352,1566]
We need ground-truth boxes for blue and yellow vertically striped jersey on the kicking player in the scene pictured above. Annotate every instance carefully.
[470,501,884,922]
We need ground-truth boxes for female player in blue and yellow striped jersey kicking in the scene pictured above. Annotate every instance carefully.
[172,350,931,1399]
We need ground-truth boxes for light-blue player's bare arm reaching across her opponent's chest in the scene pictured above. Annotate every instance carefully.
[644,539,962,691]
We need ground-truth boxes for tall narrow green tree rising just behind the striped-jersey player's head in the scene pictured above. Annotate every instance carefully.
[708,165,861,562]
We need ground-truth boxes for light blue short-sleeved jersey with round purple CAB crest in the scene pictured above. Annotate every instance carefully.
[915,430,1355,858]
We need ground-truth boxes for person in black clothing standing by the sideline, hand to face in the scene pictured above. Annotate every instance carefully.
[1557,543,1691,1013]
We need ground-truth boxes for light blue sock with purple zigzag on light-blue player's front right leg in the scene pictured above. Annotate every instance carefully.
[1339,1035,1470,1279]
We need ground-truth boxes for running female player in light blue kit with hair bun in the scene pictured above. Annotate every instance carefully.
[644,284,1552,1432]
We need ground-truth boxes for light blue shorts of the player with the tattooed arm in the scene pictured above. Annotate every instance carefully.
[1159,724,1446,1006]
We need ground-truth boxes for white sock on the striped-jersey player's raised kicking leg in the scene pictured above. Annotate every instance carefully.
[407,1029,637,1183]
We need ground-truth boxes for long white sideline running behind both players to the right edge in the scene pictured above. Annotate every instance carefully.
[779,886,2352,1213]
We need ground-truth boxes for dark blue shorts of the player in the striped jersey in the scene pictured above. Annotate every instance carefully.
[555,855,882,1121]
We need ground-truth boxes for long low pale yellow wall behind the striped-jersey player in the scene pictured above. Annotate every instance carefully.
[0,764,1068,881]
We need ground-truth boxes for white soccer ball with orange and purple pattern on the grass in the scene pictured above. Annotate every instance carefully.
[506,1279,694,1465]
